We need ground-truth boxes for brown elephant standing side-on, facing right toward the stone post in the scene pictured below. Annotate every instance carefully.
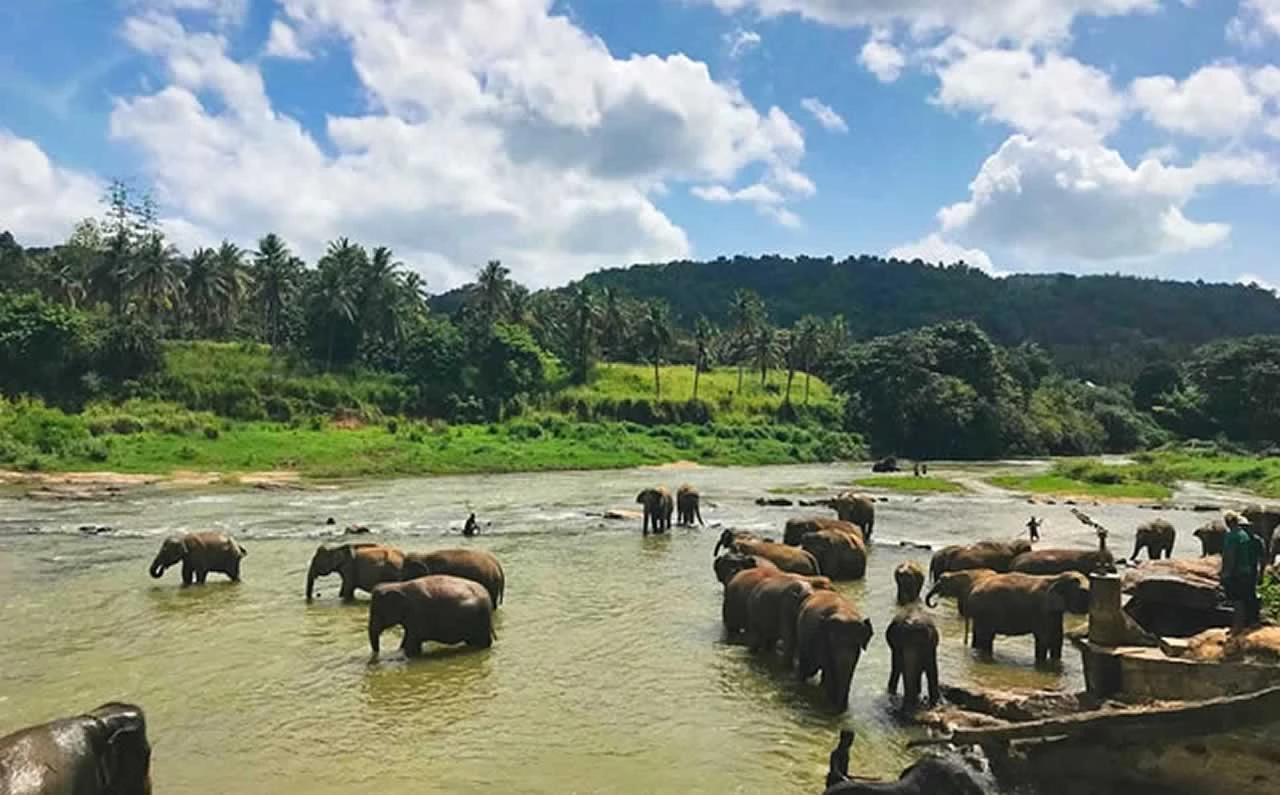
[965,571,1089,664]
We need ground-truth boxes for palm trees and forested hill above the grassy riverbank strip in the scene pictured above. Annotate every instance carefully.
[0,184,1280,463]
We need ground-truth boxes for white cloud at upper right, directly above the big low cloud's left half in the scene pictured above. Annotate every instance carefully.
[933,38,1126,142]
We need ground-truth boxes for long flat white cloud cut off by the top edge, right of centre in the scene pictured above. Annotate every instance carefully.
[707,0,1162,44]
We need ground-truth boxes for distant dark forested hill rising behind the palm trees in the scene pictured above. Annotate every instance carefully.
[431,256,1280,383]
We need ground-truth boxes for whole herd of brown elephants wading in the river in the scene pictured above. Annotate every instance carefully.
[0,485,1280,795]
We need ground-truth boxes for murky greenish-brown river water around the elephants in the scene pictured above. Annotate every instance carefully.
[0,466,1239,795]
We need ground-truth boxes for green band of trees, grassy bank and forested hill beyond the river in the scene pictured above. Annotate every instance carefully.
[0,184,1280,476]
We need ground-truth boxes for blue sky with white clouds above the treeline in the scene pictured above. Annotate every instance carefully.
[0,0,1280,292]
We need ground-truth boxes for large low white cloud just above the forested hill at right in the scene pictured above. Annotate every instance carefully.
[938,134,1276,261]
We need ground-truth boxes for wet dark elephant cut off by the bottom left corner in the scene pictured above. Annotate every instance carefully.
[0,702,151,795]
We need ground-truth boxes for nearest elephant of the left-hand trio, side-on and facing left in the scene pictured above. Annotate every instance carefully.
[369,575,494,659]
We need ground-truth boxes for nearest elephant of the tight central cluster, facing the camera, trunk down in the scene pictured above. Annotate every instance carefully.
[793,586,876,712]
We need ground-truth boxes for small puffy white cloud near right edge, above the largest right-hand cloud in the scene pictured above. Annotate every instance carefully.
[1130,64,1268,138]
